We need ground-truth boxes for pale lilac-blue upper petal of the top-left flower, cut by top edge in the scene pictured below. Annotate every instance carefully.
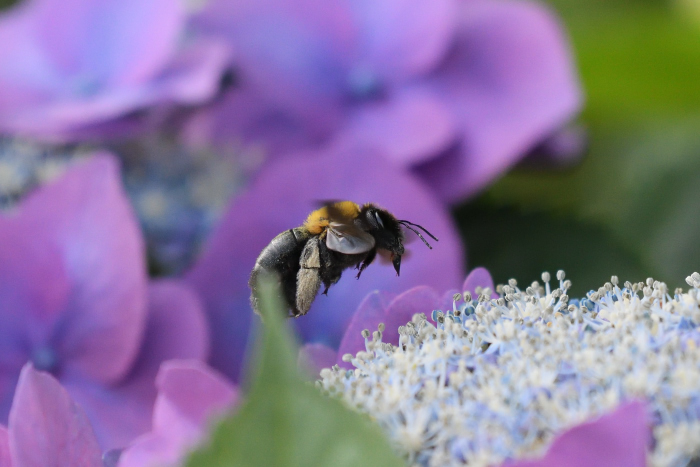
[33,0,186,86]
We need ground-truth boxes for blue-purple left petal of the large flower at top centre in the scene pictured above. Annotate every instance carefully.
[199,0,357,129]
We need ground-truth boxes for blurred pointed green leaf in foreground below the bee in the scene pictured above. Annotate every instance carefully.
[187,274,404,467]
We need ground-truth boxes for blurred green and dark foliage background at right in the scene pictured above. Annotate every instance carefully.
[454,0,700,296]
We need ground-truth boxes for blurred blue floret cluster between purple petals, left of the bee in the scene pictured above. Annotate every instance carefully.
[121,137,245,275]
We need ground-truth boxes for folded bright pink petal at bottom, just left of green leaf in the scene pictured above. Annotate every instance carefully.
[118,360,238,467]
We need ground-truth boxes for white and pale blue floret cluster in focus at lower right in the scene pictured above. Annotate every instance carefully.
[317,271,700,466]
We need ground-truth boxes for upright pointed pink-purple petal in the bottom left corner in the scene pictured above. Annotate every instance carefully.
[9,364,102,467]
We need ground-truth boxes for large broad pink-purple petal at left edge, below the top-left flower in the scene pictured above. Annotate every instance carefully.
[0,154,146,382]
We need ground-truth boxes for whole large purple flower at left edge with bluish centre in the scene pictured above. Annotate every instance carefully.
[0,154,208,448]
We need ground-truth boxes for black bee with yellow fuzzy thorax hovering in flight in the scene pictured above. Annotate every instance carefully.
[248,201,438,317]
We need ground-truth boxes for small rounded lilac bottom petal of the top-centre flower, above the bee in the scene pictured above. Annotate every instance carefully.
[339,91,458,167]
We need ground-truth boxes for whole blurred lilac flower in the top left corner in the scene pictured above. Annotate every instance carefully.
[0,0,228,140]
